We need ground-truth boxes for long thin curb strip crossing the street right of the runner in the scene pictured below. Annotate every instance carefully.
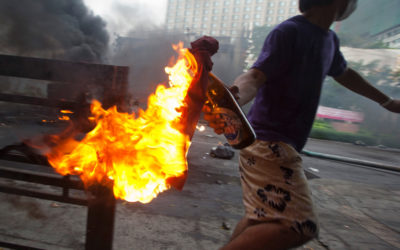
[301,150,400,172]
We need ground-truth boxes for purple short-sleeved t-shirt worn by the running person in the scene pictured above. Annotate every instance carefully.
[248,15,347,151]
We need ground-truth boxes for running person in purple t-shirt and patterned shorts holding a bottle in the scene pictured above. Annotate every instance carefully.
[205,0,400,249]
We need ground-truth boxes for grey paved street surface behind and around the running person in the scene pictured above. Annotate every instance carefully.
[0,122,400,250]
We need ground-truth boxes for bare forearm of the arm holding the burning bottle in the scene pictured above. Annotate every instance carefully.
[233,69,267,106]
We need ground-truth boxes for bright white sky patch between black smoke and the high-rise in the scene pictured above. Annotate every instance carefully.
[84,0,167,36]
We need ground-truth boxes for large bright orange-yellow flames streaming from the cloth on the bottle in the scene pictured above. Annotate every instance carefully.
[46,43,197,203]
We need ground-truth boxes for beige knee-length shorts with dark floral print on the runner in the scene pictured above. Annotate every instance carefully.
[239,140,318,237]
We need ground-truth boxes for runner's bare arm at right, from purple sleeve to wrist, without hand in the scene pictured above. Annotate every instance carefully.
[335,68,389,104]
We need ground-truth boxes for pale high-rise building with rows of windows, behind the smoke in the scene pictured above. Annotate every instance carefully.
[166,0,299,38]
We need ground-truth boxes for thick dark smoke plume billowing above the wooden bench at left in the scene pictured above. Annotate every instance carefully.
[0,0,109,62]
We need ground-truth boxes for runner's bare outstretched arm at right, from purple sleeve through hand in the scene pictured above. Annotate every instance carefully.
[334,68,400,113]
